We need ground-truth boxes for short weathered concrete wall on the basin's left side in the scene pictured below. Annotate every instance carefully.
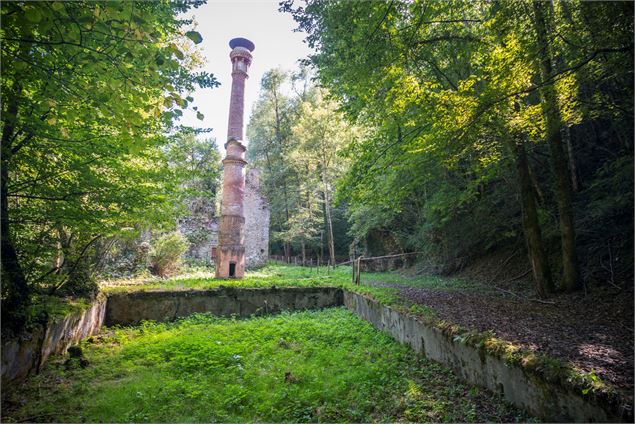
[2,294,107,385]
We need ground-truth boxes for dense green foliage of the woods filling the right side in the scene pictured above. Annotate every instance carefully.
[281,0,633,286]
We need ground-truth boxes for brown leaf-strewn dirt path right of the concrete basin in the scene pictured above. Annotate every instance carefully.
[369,281,633,396]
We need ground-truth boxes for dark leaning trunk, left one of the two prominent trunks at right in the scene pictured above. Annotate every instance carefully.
[509,140,554,298]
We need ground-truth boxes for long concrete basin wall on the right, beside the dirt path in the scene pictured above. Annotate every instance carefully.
[344,292,624,422]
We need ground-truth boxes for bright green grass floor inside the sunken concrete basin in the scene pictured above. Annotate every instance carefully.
[2,308,528,422]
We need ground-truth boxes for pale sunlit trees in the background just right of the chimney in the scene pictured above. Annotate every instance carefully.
[247,69,356,262]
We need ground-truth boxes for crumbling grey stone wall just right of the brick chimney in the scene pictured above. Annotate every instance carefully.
[244,169,270,269]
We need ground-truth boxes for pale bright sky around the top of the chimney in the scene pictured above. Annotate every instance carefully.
[181,0,311,149]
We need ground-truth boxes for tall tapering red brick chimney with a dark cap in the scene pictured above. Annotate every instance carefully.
[216,38,255,278]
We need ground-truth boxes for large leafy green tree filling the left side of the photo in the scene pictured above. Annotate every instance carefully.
[0,1,217,328]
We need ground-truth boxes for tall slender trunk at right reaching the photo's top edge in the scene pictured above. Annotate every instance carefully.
[533,1,580,291]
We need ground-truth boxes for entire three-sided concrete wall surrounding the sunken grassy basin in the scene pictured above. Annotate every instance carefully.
[2,287,633,422]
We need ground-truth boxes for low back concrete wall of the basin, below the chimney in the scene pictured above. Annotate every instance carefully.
[106,287,343,325]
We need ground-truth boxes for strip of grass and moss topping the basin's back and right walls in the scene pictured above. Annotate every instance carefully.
[102,263,620,402]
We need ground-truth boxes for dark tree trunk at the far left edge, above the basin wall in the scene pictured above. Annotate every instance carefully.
[0,90,29,330]
